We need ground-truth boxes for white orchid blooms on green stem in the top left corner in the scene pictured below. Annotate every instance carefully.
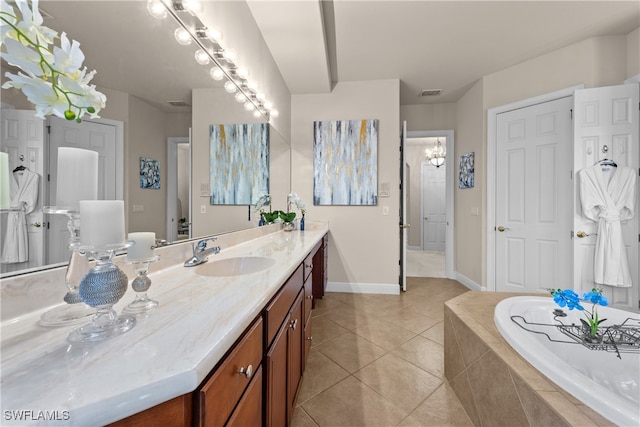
[0,0,107,122]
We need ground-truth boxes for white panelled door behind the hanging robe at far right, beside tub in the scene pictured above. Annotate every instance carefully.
[573,84,640,310]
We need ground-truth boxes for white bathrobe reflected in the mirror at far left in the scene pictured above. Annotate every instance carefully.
[2,169,40,263]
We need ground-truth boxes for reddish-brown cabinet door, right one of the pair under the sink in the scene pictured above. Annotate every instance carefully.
[287,292,304,422]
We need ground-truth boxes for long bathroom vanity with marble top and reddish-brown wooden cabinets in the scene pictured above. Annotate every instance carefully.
[2,223,328,426]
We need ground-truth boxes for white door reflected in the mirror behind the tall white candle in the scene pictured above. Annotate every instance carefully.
[47,117,116,264]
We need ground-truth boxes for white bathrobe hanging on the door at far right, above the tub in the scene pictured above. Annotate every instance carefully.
[580,164,636,287]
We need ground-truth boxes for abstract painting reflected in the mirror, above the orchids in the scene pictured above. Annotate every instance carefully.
[209,123,269,205]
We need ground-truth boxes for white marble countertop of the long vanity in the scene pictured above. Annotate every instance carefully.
[0,224,328,426]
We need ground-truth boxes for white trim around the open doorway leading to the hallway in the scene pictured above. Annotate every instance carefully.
[405,130,456,279]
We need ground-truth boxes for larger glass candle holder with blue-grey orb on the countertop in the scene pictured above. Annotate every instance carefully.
[68,245,136,342]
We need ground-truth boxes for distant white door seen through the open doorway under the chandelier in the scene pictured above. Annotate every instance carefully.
[422,162,447,252]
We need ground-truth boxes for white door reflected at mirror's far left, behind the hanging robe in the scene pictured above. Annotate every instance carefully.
[0,109,45,273]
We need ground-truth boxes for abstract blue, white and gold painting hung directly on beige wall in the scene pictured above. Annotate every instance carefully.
[313,119,378,206]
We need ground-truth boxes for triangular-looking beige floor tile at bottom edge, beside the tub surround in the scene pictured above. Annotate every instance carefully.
[400,381,473,427]
